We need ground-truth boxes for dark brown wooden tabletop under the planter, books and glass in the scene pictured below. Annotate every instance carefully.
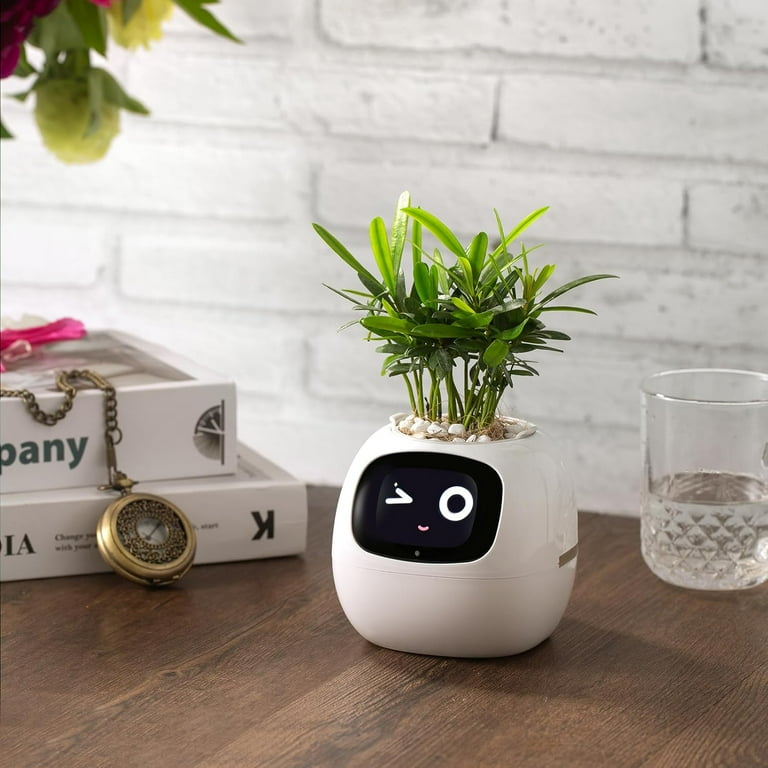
[0,488,768,768]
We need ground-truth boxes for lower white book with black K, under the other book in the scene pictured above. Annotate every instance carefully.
[0,444,307,581]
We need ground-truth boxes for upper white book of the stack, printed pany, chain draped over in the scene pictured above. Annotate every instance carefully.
[0,331,237,493]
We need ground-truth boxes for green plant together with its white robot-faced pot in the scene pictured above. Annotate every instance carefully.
[314,192,612,656]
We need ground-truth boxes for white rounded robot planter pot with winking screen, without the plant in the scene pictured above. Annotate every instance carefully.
[332,425,578,657]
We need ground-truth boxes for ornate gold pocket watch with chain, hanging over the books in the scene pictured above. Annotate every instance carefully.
[0,371,197,586]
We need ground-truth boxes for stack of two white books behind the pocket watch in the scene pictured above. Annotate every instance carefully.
[0,331,307,581]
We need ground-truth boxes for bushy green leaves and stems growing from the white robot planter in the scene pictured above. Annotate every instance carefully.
[313,192,615,430]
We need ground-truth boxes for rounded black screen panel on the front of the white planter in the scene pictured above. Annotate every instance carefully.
[352,452,502,563]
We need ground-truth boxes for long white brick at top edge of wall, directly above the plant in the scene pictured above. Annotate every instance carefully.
[320,0,699,63]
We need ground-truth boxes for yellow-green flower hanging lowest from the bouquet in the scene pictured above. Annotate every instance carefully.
[35,80,120,163]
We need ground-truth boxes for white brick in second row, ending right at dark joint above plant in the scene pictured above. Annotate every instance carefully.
[284,67,496,144]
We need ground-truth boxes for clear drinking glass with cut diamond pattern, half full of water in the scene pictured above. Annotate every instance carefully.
[640,369,768,590]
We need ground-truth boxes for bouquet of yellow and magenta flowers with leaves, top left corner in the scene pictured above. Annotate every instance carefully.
[0,0,240,163]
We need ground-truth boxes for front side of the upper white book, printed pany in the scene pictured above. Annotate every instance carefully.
[0,381,237,493]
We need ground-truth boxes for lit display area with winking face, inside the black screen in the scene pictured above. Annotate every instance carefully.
[376,467,477,548]
